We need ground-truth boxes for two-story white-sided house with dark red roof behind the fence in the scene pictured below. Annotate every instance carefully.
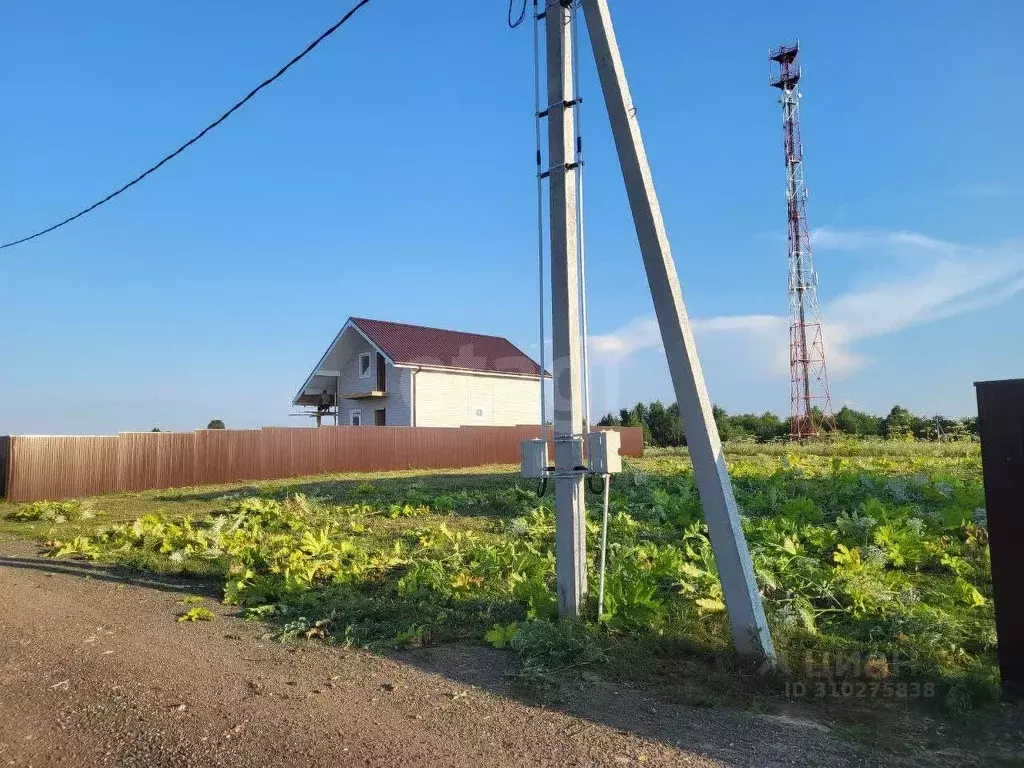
[292,317,550,427]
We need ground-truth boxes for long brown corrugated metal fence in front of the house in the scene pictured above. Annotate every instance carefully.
[0,426,643,502]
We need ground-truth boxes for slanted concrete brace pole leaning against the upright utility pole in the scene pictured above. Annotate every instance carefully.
[581,0,775,659]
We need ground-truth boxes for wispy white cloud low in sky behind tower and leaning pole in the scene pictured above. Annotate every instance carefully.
[591,227,1024,385]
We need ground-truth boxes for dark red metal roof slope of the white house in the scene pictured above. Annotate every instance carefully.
[352,317,541,376]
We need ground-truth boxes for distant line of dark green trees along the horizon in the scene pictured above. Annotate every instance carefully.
[598,400,978,447]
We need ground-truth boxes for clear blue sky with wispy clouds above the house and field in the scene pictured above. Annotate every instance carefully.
[0,0,1024,433]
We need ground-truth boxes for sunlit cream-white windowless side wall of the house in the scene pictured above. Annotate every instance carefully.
[414,371,541,427]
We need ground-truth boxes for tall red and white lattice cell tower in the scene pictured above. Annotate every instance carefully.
[769,43,835,440]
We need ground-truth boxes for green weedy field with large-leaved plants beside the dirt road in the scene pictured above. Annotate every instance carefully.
[0,441,997,729]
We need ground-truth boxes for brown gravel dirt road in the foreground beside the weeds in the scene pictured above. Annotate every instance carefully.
[0,541,983,768]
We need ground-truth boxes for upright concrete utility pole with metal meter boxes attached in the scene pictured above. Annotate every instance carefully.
[545,0,587,616]
